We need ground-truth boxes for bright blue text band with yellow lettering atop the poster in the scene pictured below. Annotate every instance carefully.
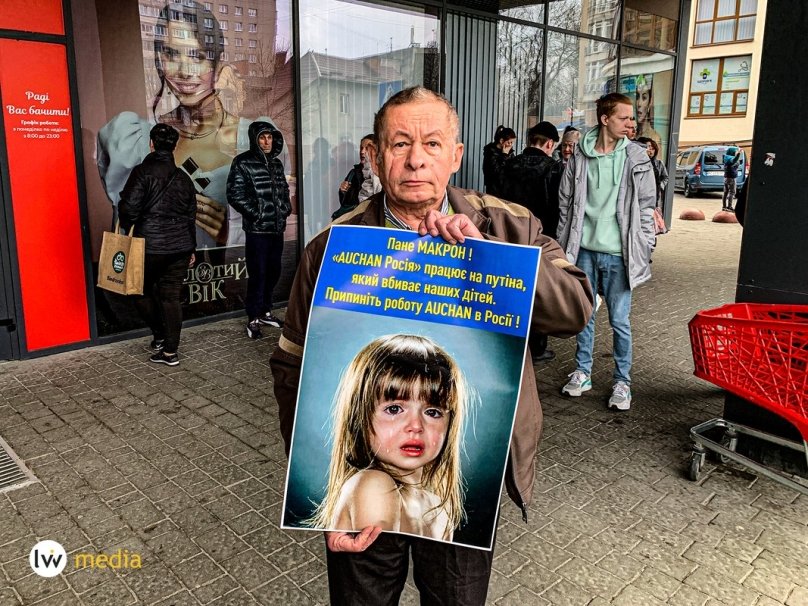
[313,226,541,336]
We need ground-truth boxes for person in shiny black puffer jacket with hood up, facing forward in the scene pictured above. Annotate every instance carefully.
[227,121,292,339]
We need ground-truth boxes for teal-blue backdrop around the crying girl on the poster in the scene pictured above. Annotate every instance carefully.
[283,307,525,548]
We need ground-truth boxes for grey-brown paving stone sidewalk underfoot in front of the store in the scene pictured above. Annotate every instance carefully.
[0,196,808,606]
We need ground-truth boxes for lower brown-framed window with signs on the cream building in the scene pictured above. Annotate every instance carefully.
[687,55,752,118]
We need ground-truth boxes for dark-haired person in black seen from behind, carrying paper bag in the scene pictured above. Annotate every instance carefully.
[118,124,196,366]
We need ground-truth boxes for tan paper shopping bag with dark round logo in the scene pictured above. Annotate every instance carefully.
[98,222,146,295]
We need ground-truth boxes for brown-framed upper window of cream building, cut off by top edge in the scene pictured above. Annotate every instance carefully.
[693,0,757,46]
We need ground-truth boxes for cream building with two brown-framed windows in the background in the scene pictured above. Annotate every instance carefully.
[679,0,766,152]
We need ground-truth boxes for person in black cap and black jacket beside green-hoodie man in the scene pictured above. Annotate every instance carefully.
[502,122,561,362]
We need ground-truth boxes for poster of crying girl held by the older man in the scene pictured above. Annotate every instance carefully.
[281,226,541,549]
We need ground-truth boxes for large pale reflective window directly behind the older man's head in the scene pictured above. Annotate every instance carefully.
[300,0,440,242]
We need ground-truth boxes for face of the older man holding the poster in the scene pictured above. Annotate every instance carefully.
[371,101,463,207]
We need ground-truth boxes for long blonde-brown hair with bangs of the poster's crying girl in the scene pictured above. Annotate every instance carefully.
[310,335,470,534]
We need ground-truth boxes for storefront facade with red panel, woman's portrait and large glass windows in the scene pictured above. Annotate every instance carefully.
[0,0,690,359]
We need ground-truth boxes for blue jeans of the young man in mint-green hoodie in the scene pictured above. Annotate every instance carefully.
[575,248,631,384]
